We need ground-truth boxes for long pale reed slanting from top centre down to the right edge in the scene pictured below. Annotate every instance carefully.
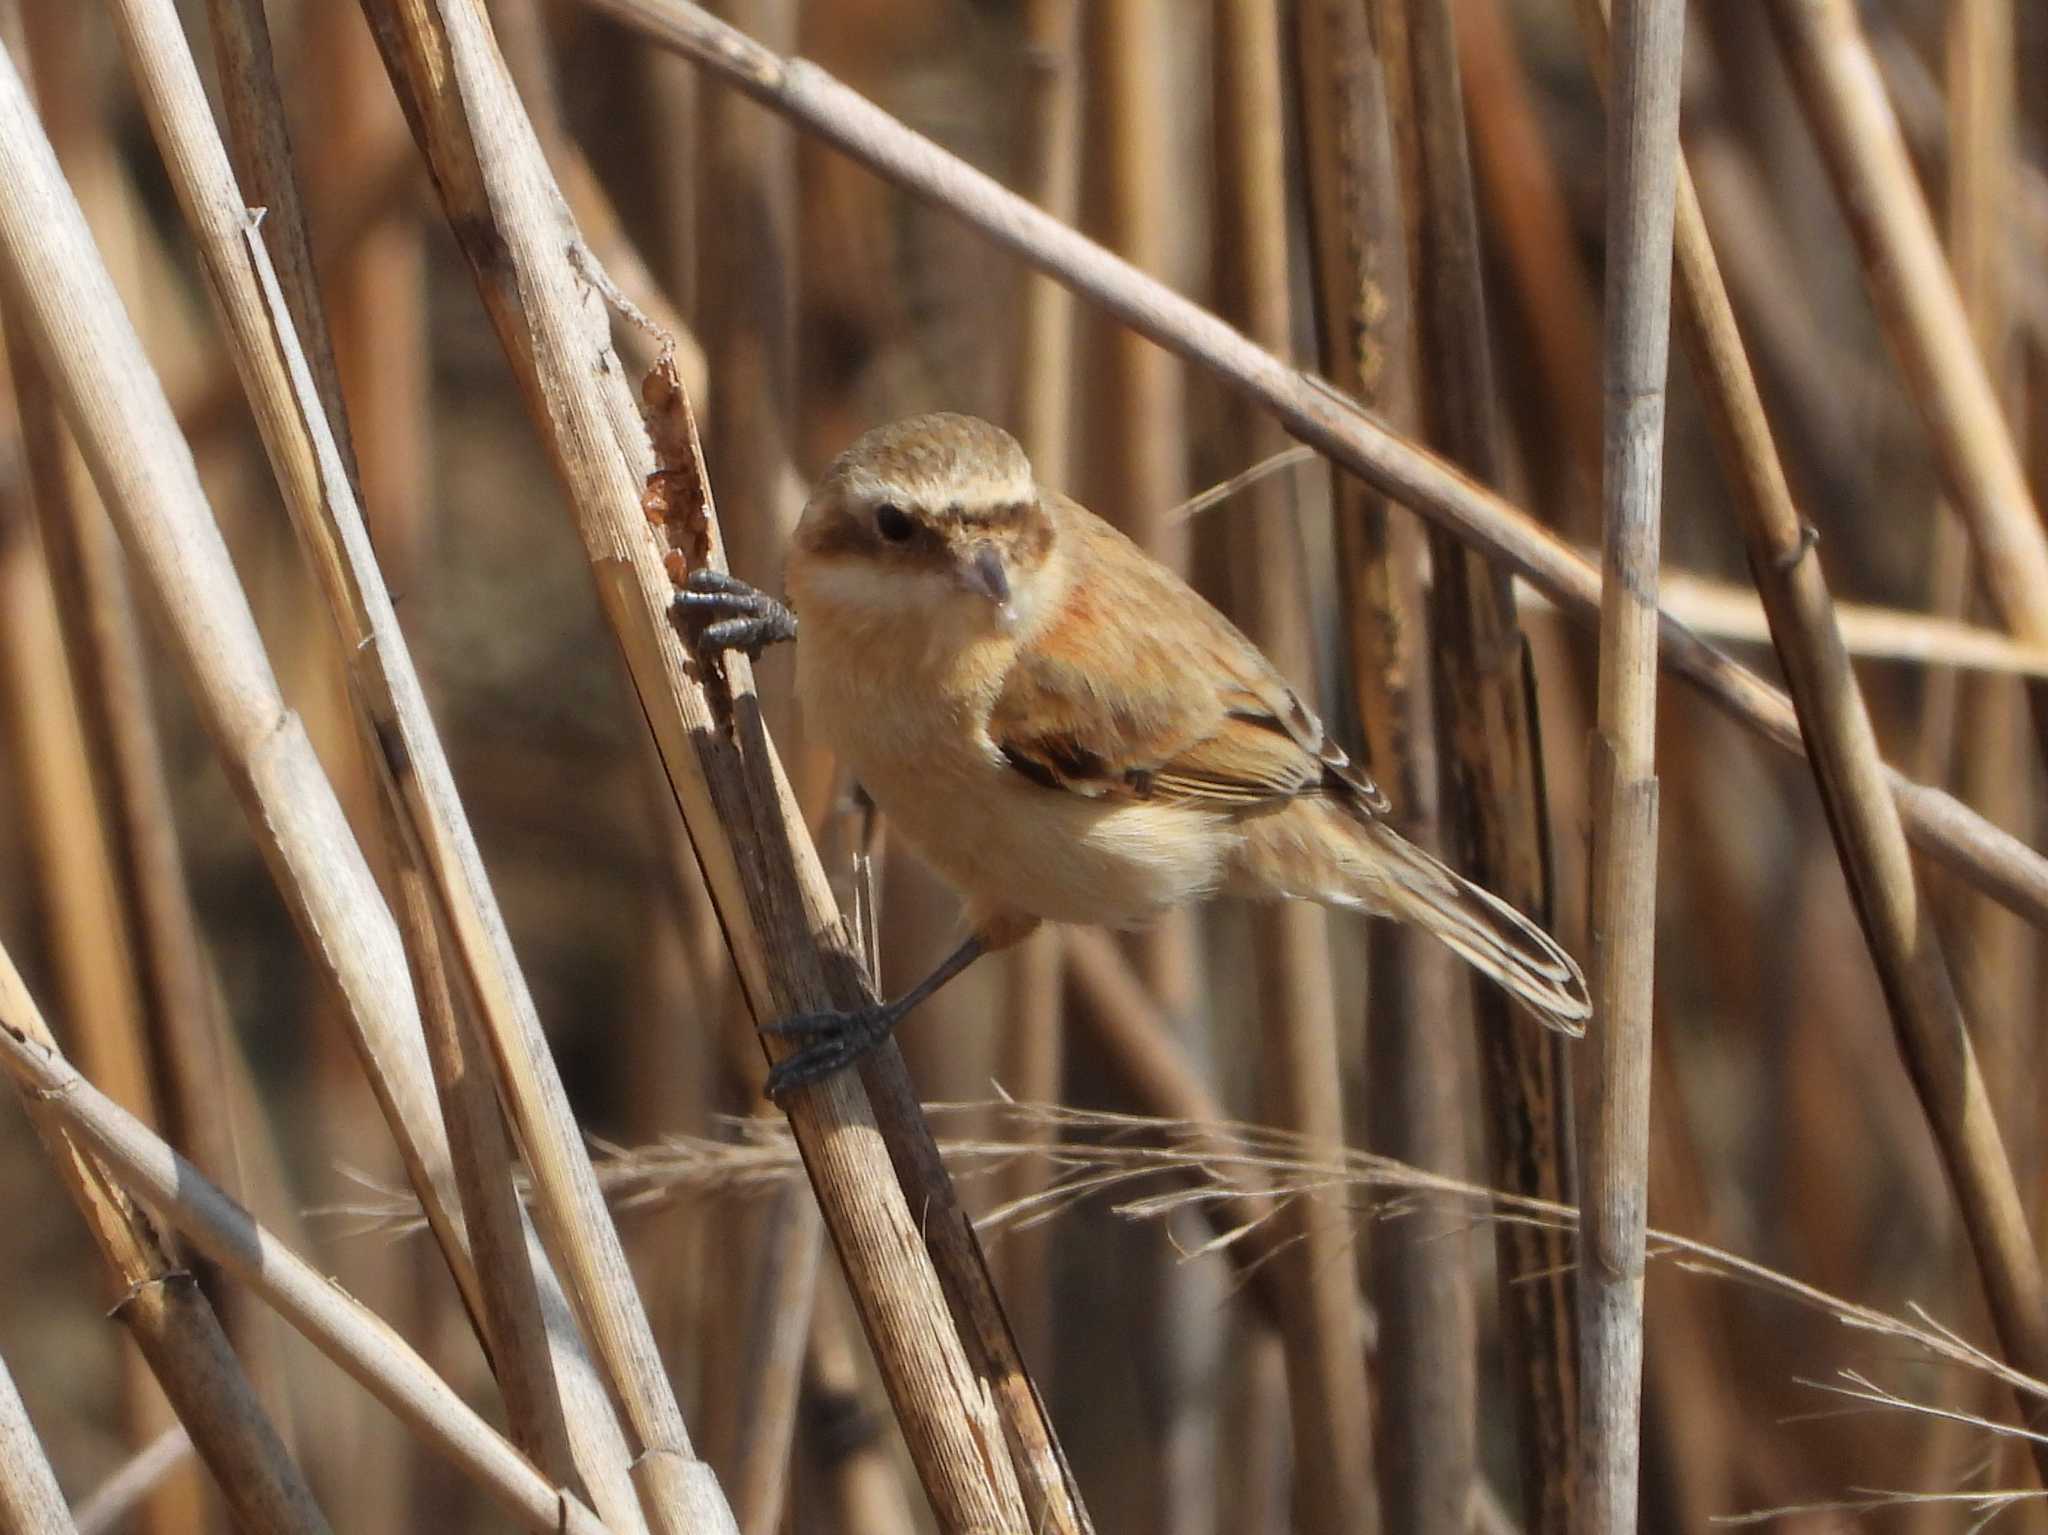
[586,0,2048,925]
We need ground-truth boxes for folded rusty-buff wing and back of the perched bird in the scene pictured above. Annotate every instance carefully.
[989,501,1389,817]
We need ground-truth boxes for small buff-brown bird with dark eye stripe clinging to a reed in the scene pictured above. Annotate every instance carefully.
[678,415,1591,1091]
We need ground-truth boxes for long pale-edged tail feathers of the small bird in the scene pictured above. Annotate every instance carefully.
[1352,819,1593,1038]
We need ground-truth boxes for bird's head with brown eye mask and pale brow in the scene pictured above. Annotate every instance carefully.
[788,415,1055,632]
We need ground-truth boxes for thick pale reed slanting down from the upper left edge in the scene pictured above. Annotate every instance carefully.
[0,6,487,1334]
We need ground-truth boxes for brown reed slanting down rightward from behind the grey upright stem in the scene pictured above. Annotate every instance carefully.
[1581,0,2048,1474]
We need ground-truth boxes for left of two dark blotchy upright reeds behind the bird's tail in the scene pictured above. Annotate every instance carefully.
[1294,0,1479,1535]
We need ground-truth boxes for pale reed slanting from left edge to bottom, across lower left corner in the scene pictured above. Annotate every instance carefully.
[0,978,606,1535]
